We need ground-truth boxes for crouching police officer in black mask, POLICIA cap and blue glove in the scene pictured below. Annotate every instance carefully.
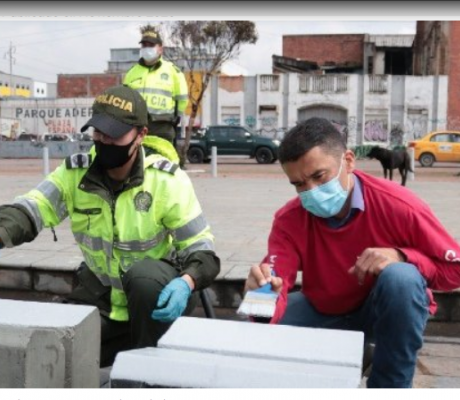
[0,86,220,366]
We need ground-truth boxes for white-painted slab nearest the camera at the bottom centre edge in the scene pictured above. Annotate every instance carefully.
[110,348,361,388]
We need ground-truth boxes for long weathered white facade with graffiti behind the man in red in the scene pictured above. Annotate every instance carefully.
[203,73,448,147]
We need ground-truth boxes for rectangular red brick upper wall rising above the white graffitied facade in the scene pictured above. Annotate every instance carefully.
[282,34,364,65]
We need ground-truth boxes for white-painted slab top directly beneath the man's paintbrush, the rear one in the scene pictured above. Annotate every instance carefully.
[158,317,364,369]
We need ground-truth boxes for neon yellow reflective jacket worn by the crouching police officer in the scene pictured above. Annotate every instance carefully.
[15,137,214,321]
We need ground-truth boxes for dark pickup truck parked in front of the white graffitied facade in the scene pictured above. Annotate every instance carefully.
[187,125,280,164]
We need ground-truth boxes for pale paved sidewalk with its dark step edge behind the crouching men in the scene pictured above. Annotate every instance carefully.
[0,168,460,387]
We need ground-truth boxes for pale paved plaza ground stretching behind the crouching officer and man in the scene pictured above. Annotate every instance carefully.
[0,158,460,387]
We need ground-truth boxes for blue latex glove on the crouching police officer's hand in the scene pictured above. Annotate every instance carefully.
[152,278,192,322]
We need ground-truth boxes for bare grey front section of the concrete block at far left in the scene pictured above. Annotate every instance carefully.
[0,326,65,388]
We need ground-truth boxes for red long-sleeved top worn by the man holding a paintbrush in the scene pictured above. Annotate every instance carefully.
[264,171,460,323]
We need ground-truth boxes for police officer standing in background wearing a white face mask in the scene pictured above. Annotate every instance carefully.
[123,25,188,142]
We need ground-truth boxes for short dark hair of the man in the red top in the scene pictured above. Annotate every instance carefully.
[278,117,347,164]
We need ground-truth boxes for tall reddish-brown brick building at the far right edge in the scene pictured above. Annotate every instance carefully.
[414,21,460,130]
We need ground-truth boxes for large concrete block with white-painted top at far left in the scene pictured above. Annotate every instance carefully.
[0,300,100,388]
